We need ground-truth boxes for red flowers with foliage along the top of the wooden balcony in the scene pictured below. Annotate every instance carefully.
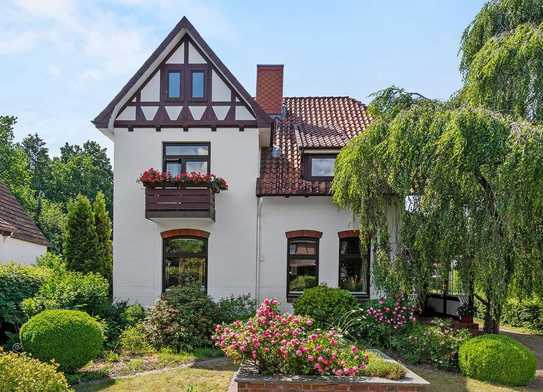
[138,168,228,193]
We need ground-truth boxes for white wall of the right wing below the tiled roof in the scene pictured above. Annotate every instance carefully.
[259,196,375,310]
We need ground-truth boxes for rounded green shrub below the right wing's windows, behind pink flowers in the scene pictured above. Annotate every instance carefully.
[294,286,358,328]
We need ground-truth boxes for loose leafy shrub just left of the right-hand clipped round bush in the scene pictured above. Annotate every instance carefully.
[391,319,471,369]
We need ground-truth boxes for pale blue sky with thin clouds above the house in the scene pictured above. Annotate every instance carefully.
[0,0,485,155]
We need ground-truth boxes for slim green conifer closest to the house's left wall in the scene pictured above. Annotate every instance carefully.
[93,192,113,282]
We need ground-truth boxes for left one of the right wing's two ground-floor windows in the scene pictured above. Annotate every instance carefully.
[287,238,319,297]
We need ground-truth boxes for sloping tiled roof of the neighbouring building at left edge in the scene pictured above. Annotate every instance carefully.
[0,183,49,246]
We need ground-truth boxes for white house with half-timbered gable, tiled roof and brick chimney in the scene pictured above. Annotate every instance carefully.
[93,18,392,307]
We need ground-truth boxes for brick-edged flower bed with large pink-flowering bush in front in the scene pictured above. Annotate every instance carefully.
[213,299,432,391]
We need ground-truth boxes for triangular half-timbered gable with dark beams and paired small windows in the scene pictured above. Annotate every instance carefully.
[93,18,271,135]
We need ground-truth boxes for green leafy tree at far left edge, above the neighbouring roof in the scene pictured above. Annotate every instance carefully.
[0,116,35,213]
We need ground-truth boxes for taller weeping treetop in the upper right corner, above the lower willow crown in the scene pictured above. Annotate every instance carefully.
[460,0,543,122]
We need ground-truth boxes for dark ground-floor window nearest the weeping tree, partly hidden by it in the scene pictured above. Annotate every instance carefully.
[339,237,370,297]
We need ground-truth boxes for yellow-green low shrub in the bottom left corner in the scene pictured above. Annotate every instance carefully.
[0,351,71,392]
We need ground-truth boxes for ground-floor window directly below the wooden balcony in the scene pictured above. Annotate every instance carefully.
[162,237,207,291]
